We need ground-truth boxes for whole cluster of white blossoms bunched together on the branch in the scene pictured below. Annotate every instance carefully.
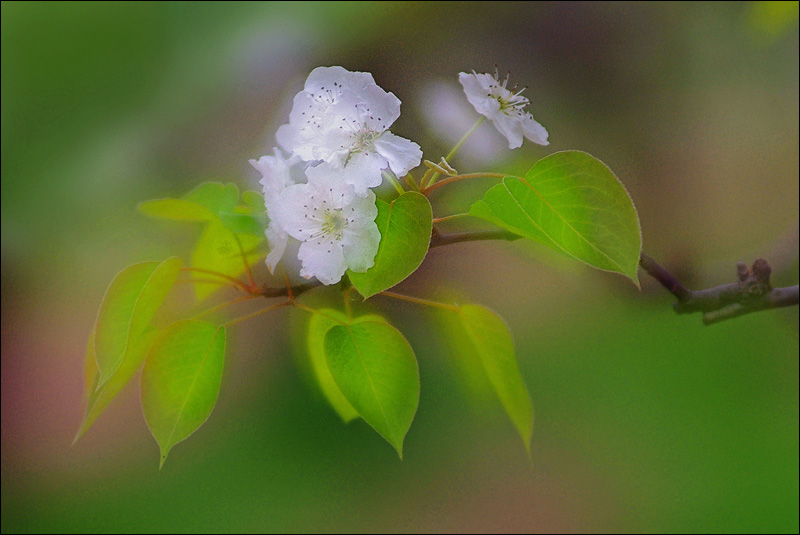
[250,67,422,284]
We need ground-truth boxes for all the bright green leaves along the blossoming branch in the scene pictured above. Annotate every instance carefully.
[81,151,641,465]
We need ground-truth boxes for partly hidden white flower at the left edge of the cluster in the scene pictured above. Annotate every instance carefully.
[250,148,306,273]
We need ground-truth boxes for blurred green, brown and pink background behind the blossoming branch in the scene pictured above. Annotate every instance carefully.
[1,2,798,533]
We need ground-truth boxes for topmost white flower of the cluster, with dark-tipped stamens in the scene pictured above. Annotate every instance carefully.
[277,67,422,196]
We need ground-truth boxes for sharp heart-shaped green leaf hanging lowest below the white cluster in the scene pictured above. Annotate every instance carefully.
[325,321,419,459]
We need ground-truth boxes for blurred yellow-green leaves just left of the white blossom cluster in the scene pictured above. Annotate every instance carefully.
[139,182,266,300]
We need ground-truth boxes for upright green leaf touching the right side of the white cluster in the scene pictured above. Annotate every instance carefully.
[348,191,433,298]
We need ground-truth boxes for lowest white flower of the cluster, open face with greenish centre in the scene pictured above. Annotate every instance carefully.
[277,163,381,284]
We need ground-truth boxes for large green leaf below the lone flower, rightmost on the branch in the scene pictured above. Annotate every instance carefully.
[470,151,642,286]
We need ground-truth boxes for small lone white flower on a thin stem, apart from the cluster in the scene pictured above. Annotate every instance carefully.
[458,71,548,149]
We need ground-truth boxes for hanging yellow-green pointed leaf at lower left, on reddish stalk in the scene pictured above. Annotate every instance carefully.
[142,320,225,466]
